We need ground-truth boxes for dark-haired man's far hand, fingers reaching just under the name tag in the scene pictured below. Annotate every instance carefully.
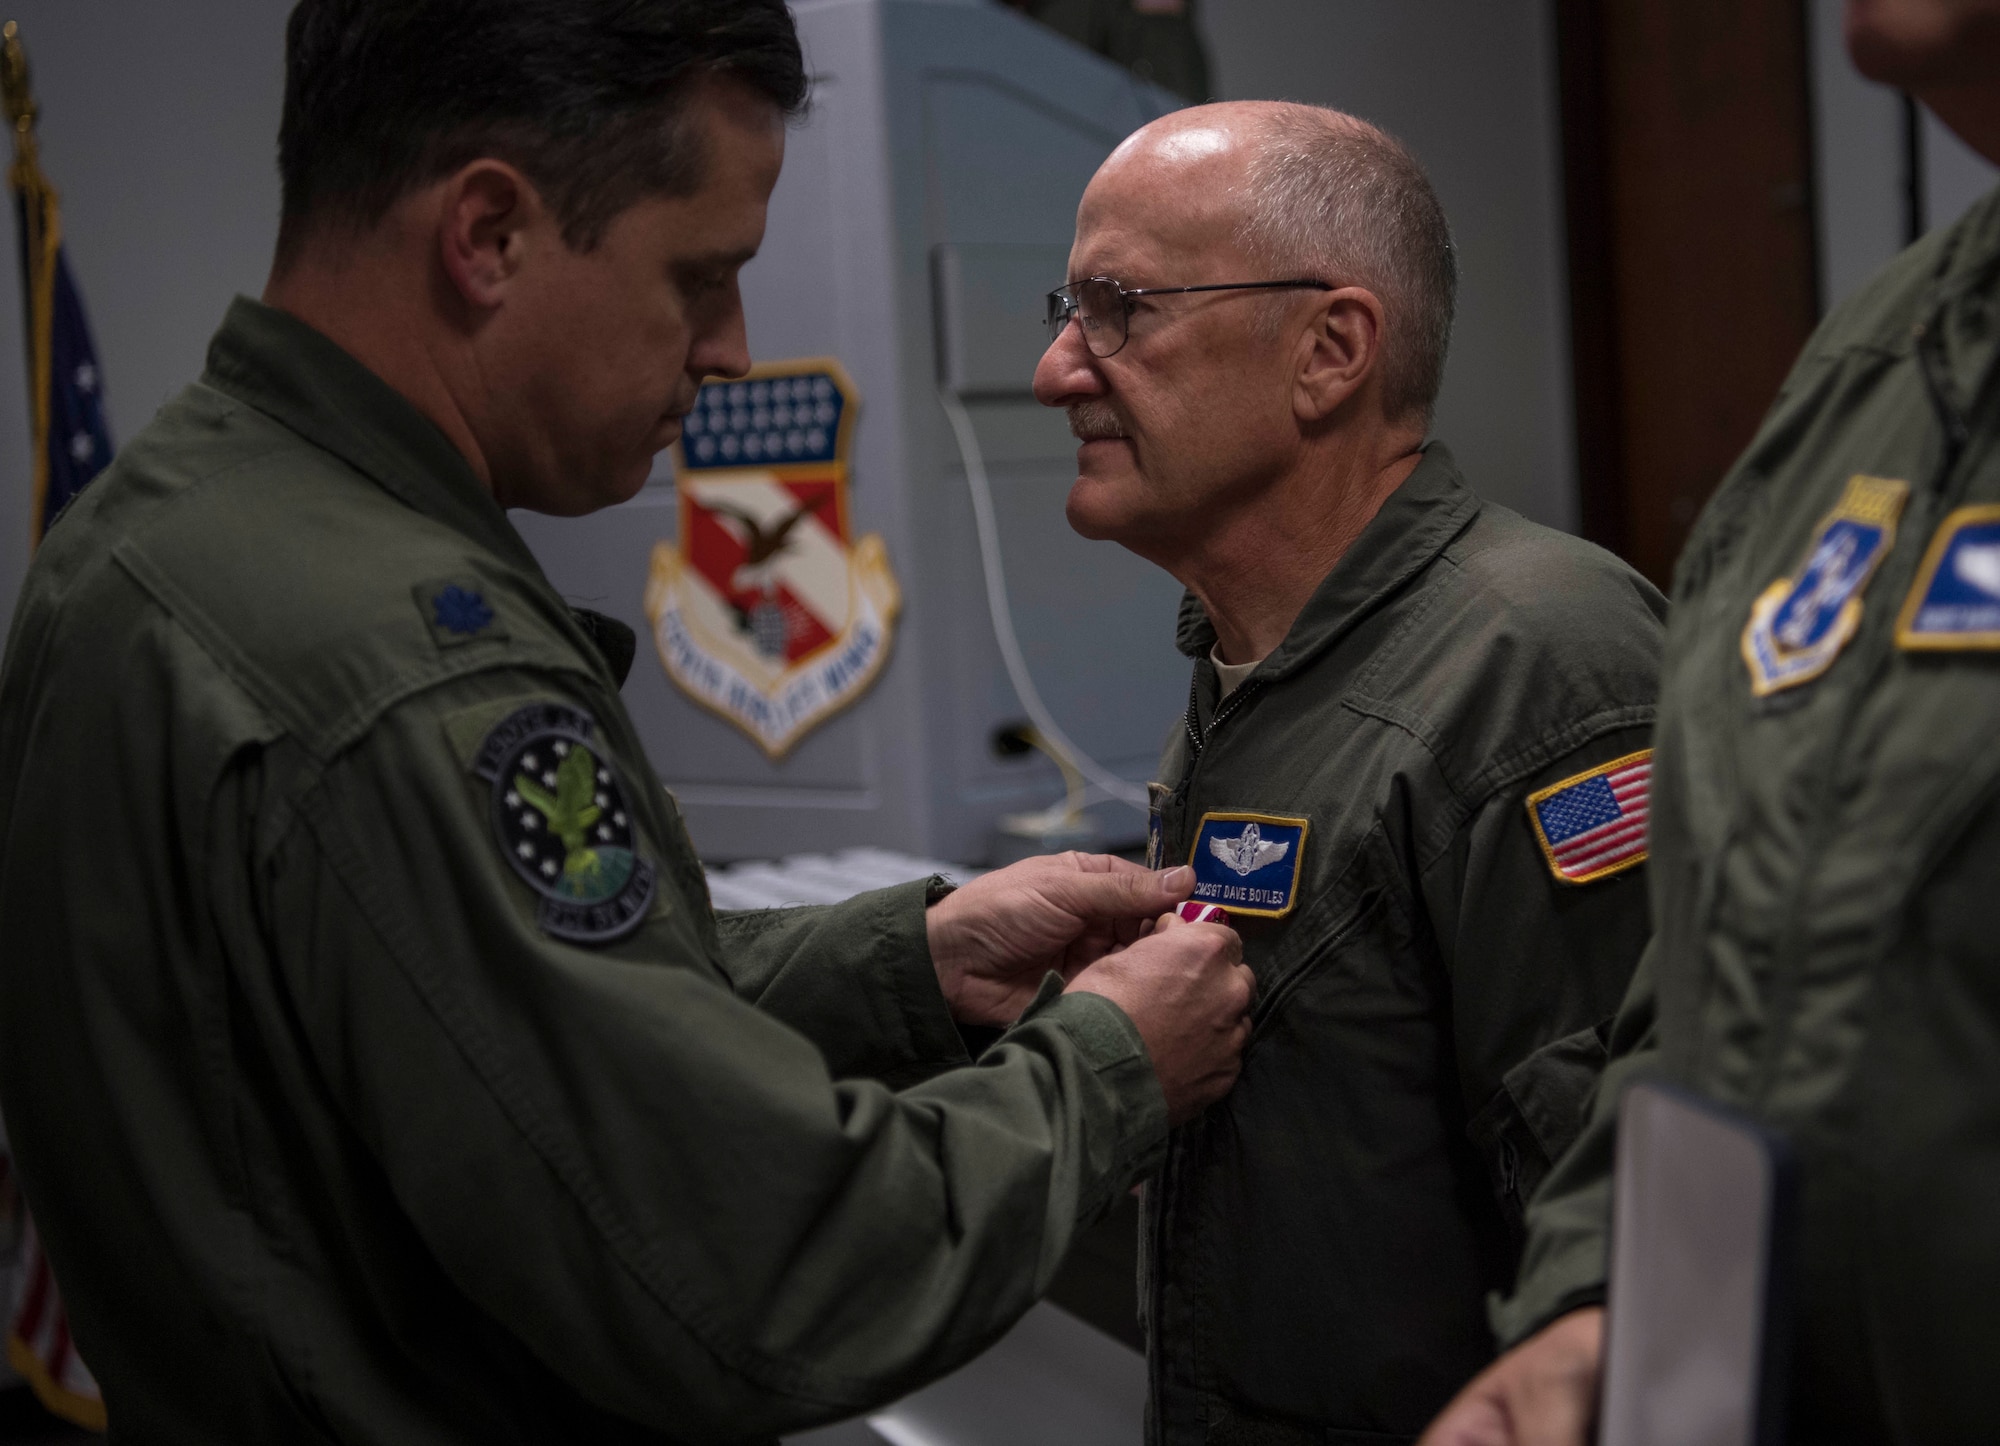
[924,854,1194,1024]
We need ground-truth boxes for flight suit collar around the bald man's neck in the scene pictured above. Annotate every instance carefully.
[1174,442,1480,686]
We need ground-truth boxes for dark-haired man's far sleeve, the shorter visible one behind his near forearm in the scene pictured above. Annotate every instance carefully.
[716,878,972,1086]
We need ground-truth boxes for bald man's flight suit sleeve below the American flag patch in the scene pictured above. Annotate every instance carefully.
[1424,728,1650,1226]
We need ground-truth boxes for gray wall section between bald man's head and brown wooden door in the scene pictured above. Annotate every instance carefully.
[1202,0,1578,528]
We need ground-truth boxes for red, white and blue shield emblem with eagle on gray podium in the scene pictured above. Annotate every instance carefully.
[646,358,902,760]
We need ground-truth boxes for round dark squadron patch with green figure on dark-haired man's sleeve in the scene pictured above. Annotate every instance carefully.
[474,702,654,944]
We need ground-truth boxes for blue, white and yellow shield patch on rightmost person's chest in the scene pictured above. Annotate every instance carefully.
[1742,476,1910,698]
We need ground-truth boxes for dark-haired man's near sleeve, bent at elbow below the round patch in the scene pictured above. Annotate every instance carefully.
[256,680,1166,1440]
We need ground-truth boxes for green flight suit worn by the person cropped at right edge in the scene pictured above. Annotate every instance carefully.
[1496,192,2000,1442]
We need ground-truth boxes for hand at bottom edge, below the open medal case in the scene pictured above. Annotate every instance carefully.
[1416,1306,1604,1446]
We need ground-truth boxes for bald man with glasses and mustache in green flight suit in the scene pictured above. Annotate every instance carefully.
[1036,104,1664,1446]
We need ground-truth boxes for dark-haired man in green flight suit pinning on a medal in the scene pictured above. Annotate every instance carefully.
[0,0,1252,1446]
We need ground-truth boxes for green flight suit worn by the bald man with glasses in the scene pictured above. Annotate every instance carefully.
[1142,444,1666,1446]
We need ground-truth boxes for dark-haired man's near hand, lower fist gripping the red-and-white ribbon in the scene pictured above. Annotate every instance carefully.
[1070,914,1256,1124]
